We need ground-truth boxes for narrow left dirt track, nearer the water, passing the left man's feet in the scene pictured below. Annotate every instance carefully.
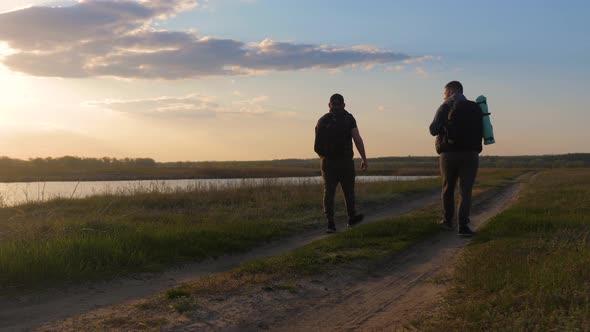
[0,193,438,331]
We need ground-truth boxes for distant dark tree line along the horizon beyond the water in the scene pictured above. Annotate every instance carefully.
[0,153,590,182]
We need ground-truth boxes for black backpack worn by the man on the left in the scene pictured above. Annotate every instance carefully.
[315,111,353,159]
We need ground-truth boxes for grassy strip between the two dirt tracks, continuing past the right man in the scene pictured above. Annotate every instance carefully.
[27,170,524,330]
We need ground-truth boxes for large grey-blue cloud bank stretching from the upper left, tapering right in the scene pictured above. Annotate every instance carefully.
[0,0,429,80]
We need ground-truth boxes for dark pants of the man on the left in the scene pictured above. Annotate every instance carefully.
[321,158,356,223]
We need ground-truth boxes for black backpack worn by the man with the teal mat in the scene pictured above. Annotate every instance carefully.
[445,100,483,152]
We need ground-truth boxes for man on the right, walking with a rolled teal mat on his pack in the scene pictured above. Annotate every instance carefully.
[430,81,483,237]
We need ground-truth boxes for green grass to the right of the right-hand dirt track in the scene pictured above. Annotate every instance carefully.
[424,170,590,331]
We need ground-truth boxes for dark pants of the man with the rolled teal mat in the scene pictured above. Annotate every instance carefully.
[440,151,479,226]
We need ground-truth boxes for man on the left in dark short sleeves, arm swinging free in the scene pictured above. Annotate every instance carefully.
[314,94,367,233]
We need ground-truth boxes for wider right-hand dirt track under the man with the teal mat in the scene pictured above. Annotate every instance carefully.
[260,184,522,331]
